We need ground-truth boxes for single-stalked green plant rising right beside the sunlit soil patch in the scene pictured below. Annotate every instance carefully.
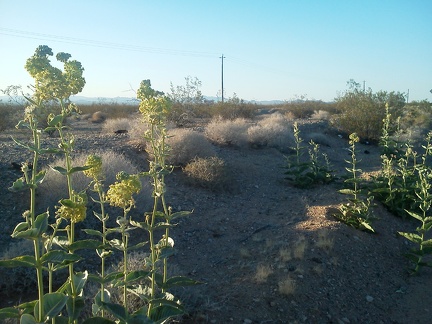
[333,133,375,232]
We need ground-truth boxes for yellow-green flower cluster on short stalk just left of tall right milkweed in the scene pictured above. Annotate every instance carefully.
[107,172,141,209]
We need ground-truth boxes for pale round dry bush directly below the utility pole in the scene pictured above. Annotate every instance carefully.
[205,117,250,147]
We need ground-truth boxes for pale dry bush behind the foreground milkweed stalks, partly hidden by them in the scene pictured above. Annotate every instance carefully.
[38,151,151,209]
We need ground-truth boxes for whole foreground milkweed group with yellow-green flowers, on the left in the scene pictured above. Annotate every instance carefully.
[0,45,198,323]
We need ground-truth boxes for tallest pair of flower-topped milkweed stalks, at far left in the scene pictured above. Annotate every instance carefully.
[0,45,85,323]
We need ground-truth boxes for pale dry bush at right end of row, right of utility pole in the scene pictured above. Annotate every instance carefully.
[248,113,294,149]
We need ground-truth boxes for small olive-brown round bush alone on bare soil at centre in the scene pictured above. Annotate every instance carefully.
[183,156,229,190]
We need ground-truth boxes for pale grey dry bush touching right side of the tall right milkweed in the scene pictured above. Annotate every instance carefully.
[167,128,216,165]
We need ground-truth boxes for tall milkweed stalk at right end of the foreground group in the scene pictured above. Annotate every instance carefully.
[131,80,196,321]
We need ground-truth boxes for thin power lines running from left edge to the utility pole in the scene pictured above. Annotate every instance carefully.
[0,27,217,57]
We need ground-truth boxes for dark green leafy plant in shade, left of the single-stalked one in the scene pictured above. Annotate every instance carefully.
[285,123,334,188]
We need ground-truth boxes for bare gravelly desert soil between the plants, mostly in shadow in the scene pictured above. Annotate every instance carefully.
[0,115,432,323]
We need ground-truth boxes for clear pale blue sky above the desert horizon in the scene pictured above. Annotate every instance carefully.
[0,0,432,101]
